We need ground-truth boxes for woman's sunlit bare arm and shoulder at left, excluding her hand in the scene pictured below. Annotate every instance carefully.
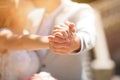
[0,0,49,53]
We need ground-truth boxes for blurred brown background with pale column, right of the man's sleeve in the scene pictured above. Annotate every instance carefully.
[73,0,120,80]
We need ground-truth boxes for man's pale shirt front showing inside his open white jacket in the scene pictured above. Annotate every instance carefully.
[37,1,62,56]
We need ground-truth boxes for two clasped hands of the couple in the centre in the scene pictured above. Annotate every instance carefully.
[48,21,77,54]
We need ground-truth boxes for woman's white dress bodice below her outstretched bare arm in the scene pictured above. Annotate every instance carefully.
[0,50,40,80]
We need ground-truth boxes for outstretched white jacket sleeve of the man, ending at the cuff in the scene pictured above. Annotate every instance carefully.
[70,5,101,53]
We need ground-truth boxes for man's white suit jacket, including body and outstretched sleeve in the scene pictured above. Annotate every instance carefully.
[35,0,99,80]
